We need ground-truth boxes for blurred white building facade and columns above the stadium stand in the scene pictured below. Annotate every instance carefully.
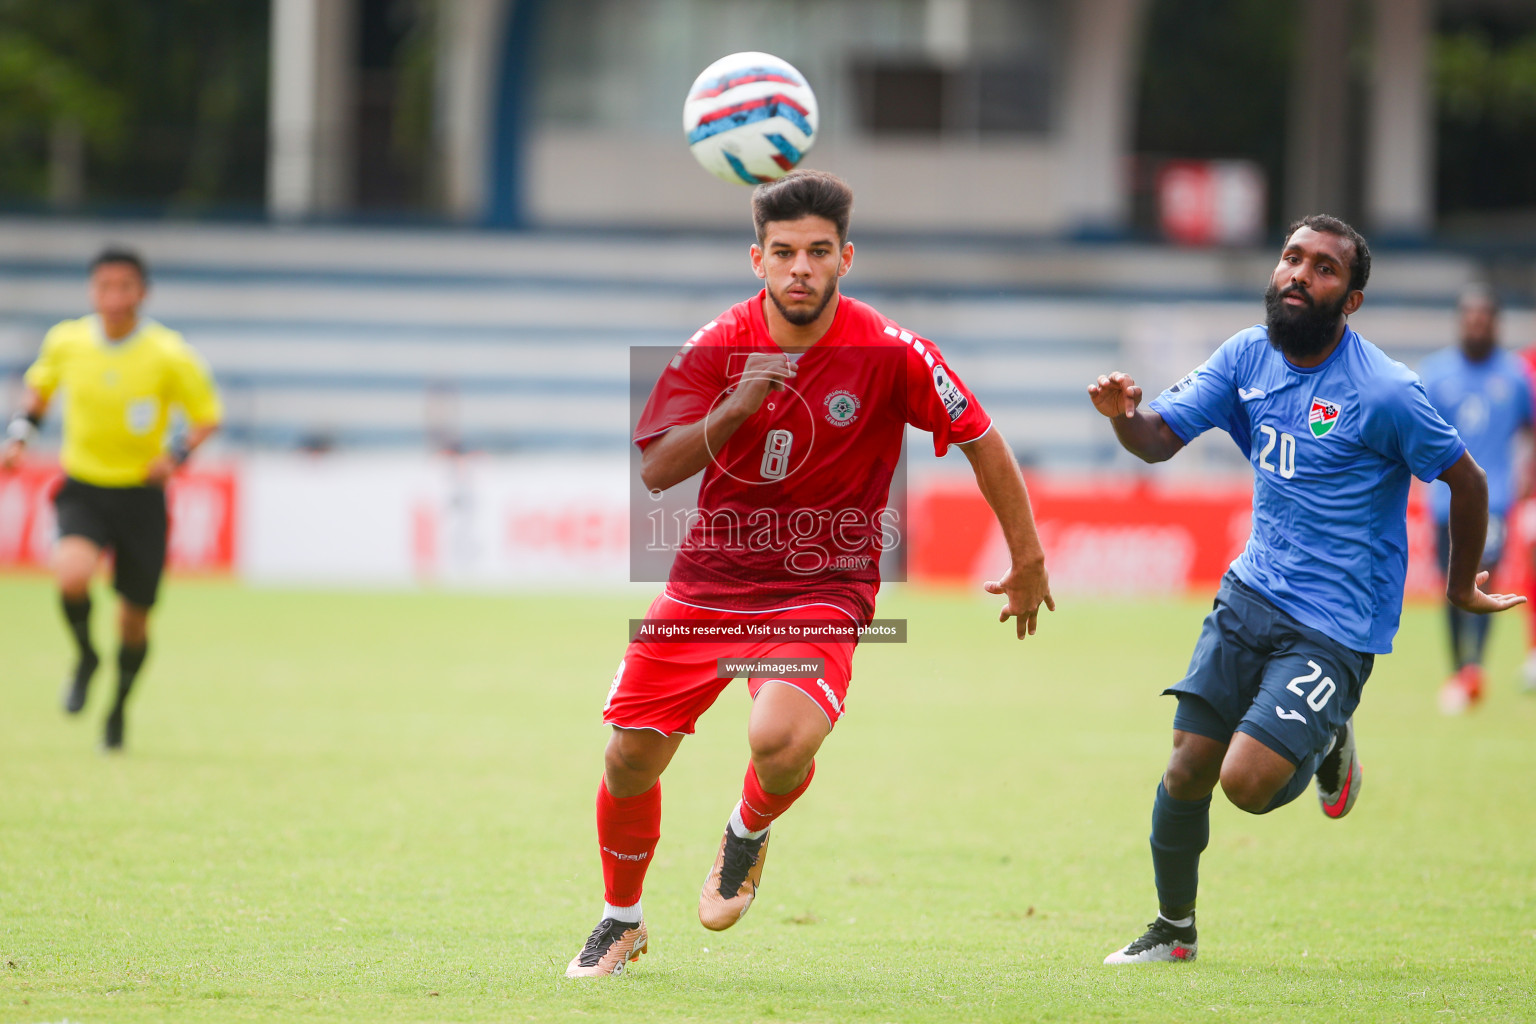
[269,0,1435,236]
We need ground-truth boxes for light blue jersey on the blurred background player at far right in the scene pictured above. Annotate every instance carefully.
[1419,348,1531,522]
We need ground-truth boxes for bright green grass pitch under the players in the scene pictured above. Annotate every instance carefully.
[0,577,1536,1024]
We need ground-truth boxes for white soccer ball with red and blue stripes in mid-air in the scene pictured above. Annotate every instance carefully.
[682,51,817,184]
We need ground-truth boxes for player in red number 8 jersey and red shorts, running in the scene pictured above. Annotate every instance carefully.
[565,170,1055,978]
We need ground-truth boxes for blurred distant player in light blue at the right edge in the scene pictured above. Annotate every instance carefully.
[1419,286,1531,714]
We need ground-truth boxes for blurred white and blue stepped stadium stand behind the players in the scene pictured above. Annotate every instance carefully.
[0,219,1536,471]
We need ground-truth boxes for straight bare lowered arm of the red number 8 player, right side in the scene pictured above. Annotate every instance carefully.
[960,430,1055,640]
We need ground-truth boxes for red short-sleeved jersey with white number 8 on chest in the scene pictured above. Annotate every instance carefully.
[634,292,992,622]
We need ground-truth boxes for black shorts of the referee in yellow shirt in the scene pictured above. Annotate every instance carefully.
[54,477,170,608]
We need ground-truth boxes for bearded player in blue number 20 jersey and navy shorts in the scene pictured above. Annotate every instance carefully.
[1087,215,1525,964]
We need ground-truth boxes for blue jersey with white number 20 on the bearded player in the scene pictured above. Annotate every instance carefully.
[1152,327,1467,654]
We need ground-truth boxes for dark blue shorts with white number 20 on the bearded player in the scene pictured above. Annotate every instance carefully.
[1163,573,1376,765]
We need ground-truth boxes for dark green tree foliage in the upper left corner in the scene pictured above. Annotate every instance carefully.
[0,0,270,207]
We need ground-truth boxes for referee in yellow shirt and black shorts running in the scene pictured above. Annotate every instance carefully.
[3,249,223,751]
